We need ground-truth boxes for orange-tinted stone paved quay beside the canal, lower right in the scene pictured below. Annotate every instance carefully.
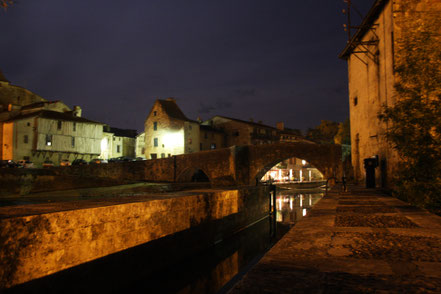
[229,187,441,294]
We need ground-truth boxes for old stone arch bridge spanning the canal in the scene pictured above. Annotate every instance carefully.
[59,143,342,187]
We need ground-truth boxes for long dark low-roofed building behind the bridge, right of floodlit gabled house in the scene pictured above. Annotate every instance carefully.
[203,115,279,147]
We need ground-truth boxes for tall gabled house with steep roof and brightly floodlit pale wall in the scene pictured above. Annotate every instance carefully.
[144,98,200,159]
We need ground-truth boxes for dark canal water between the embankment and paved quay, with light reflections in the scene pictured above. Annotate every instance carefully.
[123,190,324,294]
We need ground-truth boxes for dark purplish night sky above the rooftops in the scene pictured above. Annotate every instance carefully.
[0,0,373,131]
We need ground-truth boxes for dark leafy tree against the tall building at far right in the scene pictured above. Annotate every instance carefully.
[379,11,441,213]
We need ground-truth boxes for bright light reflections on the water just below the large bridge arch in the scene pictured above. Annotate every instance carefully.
[276,190,324,225]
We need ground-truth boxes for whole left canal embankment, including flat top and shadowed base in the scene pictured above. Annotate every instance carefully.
[0,186,270,290]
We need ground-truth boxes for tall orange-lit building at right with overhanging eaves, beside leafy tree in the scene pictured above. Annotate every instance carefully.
[339,0,441,187]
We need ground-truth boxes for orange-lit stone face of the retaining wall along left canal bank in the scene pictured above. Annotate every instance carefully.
[0,187,269,289]
